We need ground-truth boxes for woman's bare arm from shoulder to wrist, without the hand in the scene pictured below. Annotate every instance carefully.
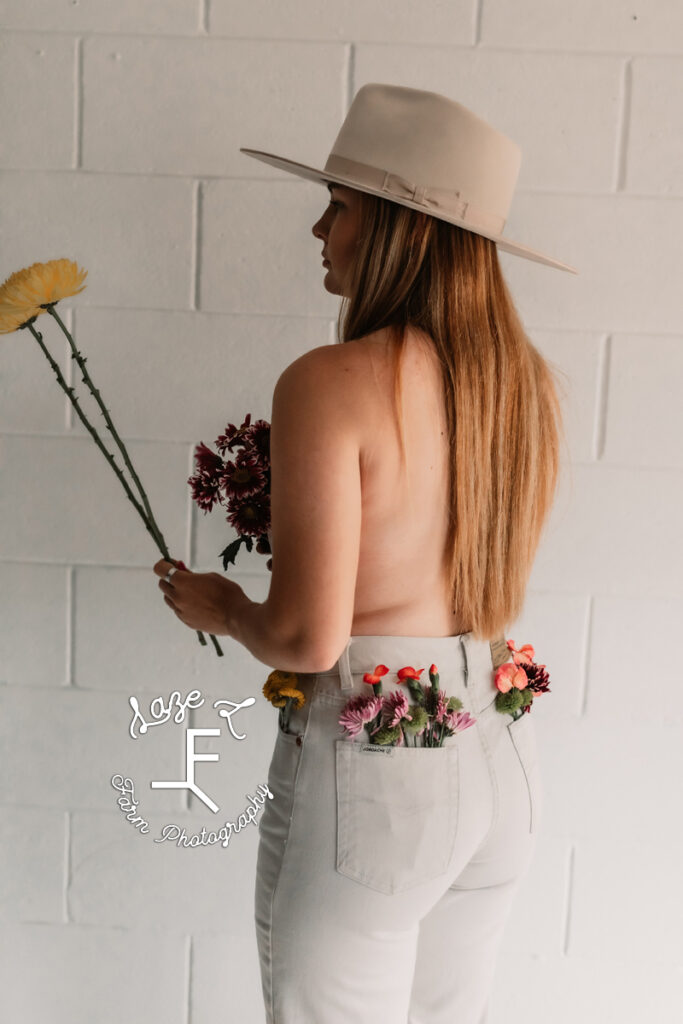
[230,345,362,672]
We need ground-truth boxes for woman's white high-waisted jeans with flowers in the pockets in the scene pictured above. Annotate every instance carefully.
[255,633,543,1024]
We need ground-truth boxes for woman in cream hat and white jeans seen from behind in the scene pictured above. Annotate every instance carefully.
[155,84,573,1024]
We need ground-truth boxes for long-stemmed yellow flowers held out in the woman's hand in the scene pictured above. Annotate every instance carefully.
[0,259,223,655]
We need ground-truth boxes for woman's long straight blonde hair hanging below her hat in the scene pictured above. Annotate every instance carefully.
[337,191,564,639]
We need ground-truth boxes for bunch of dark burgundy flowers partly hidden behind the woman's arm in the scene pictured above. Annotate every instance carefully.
[187,413,272,570]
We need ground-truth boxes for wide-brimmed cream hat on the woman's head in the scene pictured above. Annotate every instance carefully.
[240,82,579,273]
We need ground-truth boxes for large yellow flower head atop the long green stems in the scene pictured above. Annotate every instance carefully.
[0,259,88,334]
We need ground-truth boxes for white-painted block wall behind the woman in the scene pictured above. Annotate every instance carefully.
[0,0,683,1024]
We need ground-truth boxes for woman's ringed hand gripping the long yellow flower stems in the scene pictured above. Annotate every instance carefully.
[153,558,251,636]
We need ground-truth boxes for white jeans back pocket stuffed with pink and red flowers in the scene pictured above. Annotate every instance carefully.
[336,739,459,893]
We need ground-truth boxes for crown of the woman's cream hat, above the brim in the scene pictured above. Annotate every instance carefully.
[325,82,521,221]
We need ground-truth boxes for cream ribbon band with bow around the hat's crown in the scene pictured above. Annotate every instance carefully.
[325,154,505,234]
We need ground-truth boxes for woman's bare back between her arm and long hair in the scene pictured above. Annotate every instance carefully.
[344,330,471,636]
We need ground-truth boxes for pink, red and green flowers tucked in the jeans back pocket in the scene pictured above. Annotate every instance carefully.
[339,665,476,746]
